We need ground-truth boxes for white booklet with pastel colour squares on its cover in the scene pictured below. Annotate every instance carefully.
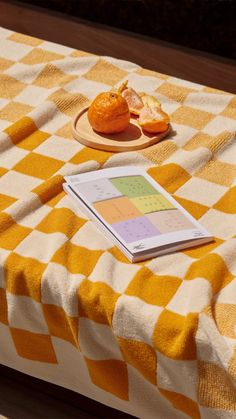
[63,166,212,262]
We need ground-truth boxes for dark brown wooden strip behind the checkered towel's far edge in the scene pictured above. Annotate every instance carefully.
[0,0,236,93]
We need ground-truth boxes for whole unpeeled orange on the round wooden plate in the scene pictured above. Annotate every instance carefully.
[88,92,130,134]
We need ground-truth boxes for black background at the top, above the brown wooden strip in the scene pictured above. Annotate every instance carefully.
[17,0,236,59]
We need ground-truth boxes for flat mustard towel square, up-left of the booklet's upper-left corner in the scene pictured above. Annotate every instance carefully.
[13,152,64,180]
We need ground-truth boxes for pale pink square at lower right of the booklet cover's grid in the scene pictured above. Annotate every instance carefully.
[146,209,195,234]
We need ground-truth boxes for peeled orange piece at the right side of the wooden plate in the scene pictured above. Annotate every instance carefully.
[138,105,170,133]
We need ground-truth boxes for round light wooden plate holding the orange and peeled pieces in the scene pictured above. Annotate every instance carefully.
[72,106,170,151]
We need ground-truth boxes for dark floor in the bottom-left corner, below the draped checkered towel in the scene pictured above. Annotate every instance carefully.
[0,365,135,419]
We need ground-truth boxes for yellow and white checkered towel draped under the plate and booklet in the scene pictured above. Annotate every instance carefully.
[0,29,236,419]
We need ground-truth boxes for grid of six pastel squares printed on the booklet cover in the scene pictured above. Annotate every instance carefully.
[76,175,194,243]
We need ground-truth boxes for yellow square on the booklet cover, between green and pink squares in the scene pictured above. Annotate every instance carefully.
[130,194,175,214]
